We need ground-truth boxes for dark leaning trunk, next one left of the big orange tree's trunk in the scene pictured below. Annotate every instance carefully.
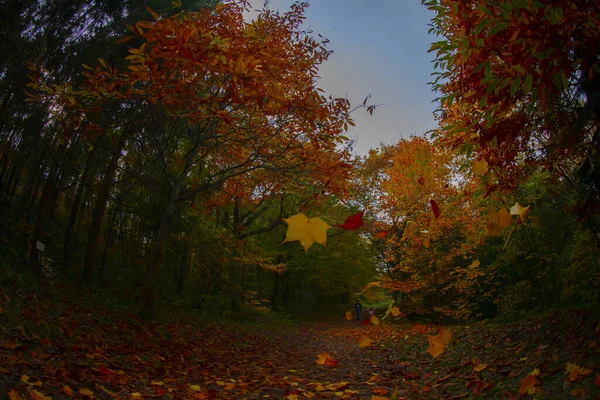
[82,130,129,283]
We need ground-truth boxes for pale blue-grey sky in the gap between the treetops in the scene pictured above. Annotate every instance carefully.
[246,0,437,155]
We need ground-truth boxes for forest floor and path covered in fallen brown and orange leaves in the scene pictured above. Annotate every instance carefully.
[0,282,600,400]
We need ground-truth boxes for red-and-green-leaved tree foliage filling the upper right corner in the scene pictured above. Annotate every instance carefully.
[423,0,600,246]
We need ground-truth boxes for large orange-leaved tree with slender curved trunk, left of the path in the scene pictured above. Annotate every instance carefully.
[30,2,349,317]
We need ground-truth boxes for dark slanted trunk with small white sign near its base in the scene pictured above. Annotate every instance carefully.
[29,141,67,273]
